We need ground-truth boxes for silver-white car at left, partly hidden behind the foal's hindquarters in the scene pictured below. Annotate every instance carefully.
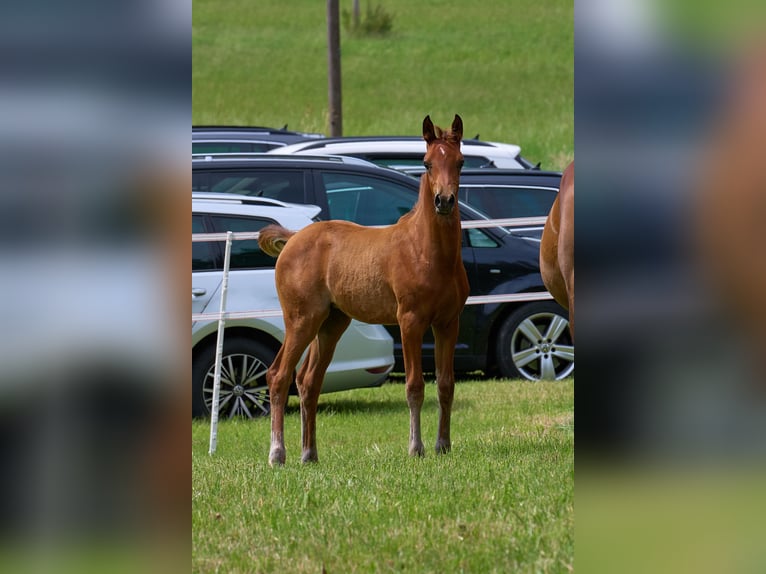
[192,193,394,417]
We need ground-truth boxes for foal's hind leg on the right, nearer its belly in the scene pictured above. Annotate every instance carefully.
[297,309,351,463]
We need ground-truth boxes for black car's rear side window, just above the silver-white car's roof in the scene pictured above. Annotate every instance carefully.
[192,170,305,203]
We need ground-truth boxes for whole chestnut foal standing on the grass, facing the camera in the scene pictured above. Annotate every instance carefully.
[258,114,469,466]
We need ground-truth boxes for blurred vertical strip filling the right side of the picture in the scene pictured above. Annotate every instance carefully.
[575,0,766,572]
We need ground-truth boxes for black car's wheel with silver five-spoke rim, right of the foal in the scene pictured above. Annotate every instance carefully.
[496,301,574,381]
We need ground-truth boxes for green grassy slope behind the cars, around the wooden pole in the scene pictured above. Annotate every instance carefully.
[192,0,574,169]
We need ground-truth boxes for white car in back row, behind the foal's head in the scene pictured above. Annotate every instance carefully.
[266,136,535,171]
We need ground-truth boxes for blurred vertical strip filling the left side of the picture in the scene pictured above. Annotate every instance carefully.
[0,0,191,572]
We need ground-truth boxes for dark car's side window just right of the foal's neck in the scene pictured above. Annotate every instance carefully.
[458,185,556,219]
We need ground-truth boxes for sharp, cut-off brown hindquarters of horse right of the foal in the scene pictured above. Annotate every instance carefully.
[540,160,574,340]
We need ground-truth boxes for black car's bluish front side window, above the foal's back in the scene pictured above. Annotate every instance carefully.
[321,172,417,225]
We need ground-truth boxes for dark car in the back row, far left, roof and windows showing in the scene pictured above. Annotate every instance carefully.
[192,126,324,154]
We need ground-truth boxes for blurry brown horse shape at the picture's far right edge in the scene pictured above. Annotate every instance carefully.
[690,44,766,388]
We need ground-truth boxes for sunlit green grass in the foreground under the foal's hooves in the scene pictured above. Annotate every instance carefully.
[192,379,574,573]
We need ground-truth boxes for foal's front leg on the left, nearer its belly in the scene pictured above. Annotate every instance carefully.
[399,319,425,456]
